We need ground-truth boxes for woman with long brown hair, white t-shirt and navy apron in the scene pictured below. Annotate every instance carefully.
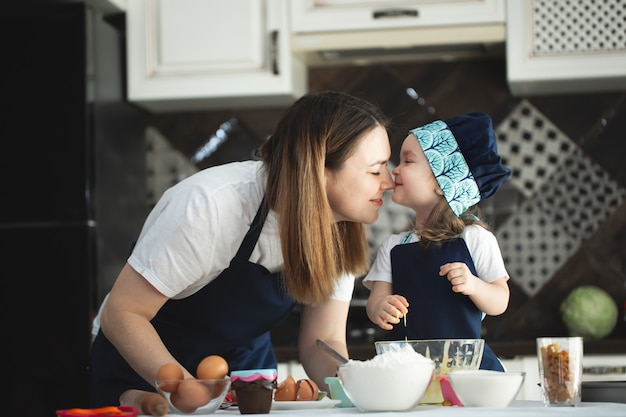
[91,92,394,412]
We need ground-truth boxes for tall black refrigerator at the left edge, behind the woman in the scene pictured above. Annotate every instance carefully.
[0,1,147,417]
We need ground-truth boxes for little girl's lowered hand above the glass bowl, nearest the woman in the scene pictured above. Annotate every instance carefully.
[366,281,409,330]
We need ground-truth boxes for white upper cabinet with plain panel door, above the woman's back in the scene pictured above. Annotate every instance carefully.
[126,0,307,112]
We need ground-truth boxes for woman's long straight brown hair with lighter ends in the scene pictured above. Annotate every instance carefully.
[259,91,388,304]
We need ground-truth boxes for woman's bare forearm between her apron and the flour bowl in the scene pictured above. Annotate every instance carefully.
[298,300,350,392]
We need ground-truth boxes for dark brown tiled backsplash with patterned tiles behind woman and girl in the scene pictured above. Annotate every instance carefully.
[151,59,626,341]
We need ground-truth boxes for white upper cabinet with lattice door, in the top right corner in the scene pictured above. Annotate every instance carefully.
[506,0,626,96]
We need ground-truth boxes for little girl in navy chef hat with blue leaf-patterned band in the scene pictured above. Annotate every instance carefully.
[363,113,511,371]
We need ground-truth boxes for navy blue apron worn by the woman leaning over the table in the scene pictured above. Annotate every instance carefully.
[90,203,295,407]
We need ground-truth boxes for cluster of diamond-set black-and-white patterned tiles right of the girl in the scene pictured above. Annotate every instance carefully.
[495,101,626,296]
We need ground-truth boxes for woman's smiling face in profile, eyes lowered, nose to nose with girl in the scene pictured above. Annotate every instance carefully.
[326,126,394,224]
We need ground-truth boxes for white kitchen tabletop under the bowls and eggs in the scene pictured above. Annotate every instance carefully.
[145,400,626,417]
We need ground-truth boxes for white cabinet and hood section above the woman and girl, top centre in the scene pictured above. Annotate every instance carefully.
[290,0,506,65]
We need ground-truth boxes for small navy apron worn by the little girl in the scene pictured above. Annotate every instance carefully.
[382,238,504,371]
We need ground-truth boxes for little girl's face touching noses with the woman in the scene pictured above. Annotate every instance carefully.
[391,133,443,220]
